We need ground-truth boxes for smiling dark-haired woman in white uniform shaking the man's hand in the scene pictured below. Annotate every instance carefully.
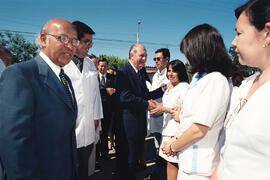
[151,60,189,180]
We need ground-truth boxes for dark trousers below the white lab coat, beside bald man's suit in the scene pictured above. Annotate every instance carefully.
[77,143,94,180]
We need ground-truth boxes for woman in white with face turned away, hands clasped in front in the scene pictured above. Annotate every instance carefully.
[162,24,232,180]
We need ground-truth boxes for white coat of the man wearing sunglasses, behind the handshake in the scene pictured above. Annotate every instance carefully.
[147,68,169,133]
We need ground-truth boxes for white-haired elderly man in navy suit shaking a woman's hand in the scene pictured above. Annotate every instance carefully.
[116,44,163,180]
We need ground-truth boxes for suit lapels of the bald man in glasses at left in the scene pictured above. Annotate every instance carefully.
[35,56,76,111]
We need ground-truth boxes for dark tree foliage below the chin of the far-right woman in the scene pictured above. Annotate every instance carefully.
[229,46,259,77]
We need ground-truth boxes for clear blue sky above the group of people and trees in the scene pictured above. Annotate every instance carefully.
[0,0,246,66]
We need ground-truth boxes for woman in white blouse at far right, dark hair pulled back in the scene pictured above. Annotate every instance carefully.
[213,0,270,180]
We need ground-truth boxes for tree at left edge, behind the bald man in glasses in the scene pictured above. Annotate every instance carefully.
[0,32,38,63]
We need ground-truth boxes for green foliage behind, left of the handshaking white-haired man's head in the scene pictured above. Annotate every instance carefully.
[98,54,128,71]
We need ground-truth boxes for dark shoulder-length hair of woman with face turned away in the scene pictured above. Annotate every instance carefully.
[180,24,232,77]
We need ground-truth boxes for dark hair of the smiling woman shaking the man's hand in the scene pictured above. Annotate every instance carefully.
[167,59,189,83]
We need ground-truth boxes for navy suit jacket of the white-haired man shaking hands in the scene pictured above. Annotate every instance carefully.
[116,63,163,140]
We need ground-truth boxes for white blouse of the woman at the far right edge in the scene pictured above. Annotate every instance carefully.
[218,73,270,180]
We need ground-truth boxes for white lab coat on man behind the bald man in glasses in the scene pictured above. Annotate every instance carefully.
[64,57,103,148]
